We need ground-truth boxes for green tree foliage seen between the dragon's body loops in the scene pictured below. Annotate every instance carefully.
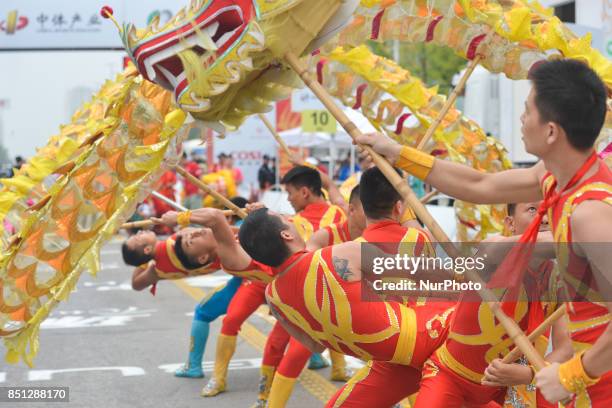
[368,41,467,94]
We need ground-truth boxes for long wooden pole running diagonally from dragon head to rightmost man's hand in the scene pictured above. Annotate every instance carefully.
[285,52,545,370]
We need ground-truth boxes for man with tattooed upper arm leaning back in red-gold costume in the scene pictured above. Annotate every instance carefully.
[234,167,452,406]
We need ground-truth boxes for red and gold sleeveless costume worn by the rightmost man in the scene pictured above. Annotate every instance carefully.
[542,160,612,408]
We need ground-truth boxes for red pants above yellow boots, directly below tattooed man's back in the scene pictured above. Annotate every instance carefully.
[261,322,312,378]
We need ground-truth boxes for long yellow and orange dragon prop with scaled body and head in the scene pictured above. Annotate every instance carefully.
[0,0,612,364]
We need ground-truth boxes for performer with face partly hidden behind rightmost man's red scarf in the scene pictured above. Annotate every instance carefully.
[415,203,573,408]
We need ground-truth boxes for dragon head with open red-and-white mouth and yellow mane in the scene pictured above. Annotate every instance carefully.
[102,0,359,128]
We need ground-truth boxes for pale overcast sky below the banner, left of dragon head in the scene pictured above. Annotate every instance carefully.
[0,51,125,157]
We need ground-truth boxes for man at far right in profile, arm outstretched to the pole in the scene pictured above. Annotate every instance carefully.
[358,60,612,407]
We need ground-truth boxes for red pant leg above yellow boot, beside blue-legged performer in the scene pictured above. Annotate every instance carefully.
[221,280,266,336]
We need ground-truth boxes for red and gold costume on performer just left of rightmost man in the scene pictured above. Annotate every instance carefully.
[416,261,556,408]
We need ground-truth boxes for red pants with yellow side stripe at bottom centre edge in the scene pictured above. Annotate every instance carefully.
[325,361,420,408]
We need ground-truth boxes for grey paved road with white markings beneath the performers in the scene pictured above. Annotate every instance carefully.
[0,240,354,408]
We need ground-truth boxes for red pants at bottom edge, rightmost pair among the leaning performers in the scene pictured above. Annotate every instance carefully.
[415,360,506,408]
